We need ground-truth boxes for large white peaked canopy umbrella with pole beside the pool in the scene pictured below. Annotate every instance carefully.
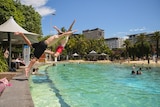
[0,16,39,68]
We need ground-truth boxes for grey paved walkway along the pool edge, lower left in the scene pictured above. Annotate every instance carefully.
[0,72,34,107]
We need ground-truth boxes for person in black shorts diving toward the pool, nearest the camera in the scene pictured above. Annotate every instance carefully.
[14,20,76,77]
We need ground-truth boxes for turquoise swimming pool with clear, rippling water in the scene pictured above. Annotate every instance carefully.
[30,63,160,107]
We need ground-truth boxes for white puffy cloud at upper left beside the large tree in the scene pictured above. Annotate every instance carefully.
[20,0,56,16]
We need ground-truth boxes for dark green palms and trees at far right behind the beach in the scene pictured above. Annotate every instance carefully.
[124,32,160,60]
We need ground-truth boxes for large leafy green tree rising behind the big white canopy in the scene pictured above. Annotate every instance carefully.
[0,0,42,34]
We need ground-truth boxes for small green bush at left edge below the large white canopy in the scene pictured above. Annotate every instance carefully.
[0,51,8,72]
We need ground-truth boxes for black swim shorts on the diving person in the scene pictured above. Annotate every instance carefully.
[32,41,47,59]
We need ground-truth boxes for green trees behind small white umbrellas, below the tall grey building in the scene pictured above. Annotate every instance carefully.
[65,35,111,56]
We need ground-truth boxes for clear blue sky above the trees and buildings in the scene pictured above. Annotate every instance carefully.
[20,0,160,38]
